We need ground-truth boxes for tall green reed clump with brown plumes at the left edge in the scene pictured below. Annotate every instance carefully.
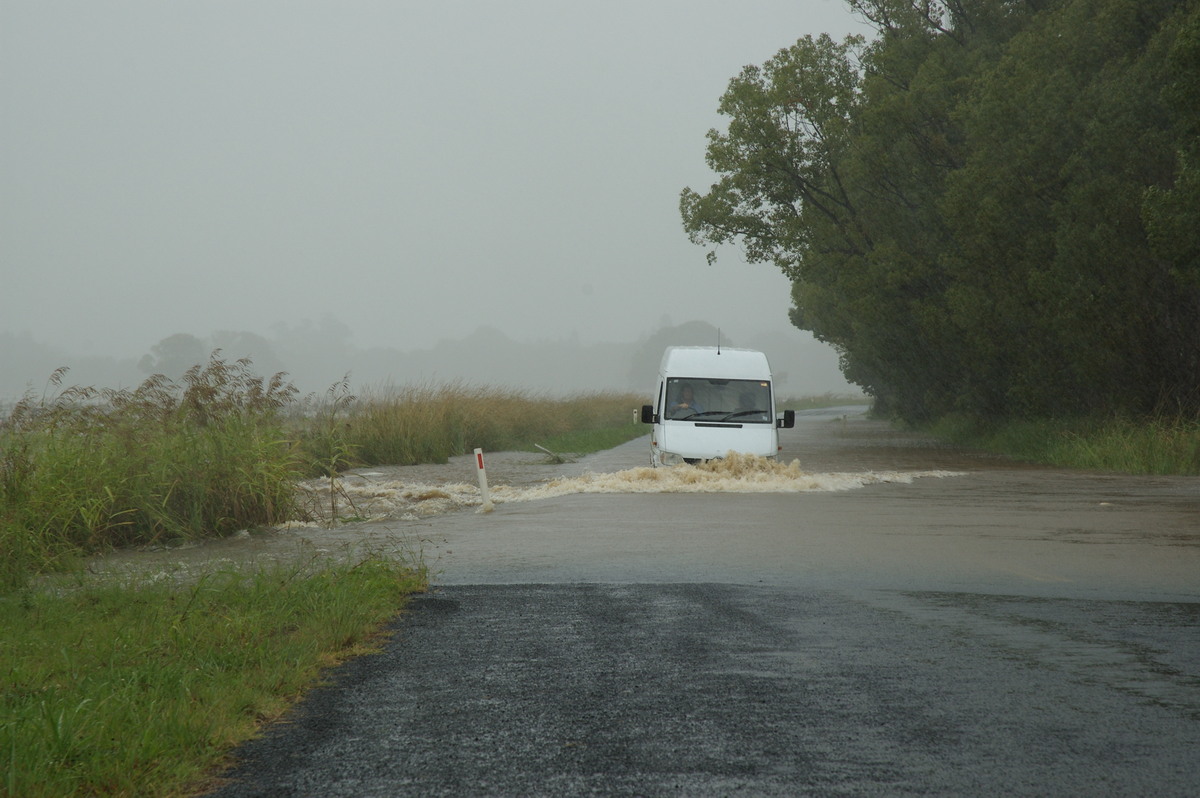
[0,353,296,584]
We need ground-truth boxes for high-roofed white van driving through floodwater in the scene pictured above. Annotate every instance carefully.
[642,347,796,466]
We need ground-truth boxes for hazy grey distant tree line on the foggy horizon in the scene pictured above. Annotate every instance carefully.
[0,317,860,404]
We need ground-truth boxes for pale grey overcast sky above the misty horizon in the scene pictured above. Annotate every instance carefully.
[0,0,865,356]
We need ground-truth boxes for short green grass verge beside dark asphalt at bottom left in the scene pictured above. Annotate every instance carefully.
[0,558,424,798]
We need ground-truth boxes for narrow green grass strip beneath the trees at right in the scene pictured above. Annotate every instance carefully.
[929,416,1200,475]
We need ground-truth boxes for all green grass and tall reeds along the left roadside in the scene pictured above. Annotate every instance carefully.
[0,353,644,798]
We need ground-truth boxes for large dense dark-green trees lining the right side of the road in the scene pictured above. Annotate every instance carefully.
[680,0,1200,419]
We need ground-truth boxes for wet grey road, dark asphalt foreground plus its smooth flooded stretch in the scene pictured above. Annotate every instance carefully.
[212,408,1200,798]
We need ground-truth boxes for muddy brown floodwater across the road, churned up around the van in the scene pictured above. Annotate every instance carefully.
[94,407,1200,600]
